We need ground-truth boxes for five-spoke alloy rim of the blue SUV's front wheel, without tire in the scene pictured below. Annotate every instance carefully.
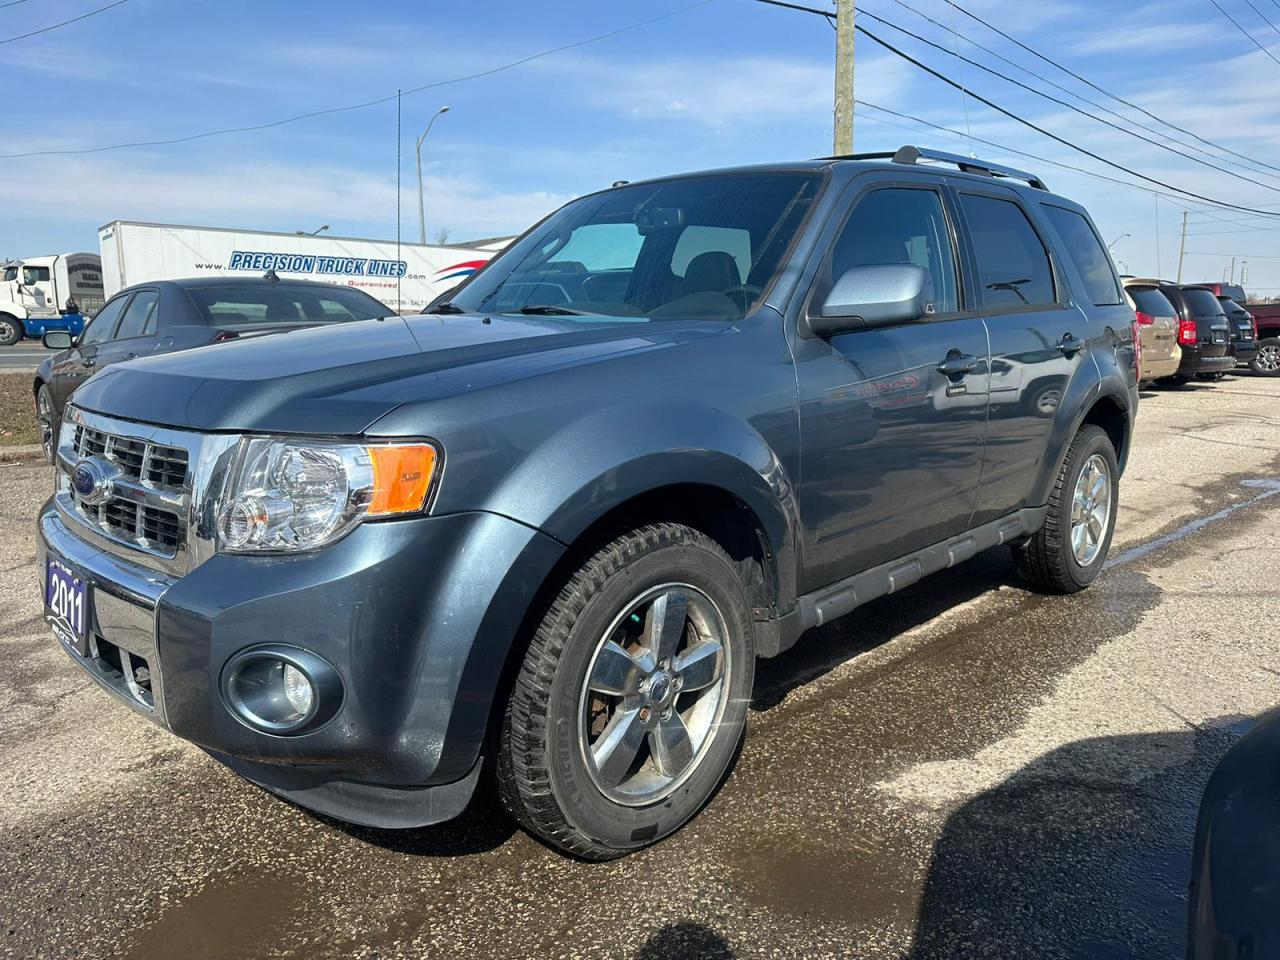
[579,584,732,806]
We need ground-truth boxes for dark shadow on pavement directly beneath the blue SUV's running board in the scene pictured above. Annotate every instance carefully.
[751,548,1025,710]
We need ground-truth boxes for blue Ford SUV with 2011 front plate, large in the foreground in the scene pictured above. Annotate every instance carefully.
[40,147,1138,859]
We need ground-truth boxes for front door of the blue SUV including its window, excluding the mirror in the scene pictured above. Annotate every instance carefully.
[796,180,988,590]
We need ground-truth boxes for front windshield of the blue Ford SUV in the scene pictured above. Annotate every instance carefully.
[448,173,820,320]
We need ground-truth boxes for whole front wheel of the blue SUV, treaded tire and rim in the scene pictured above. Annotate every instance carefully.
[497,524,755,860]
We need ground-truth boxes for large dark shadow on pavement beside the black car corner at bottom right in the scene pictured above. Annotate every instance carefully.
[909,716,1254,960]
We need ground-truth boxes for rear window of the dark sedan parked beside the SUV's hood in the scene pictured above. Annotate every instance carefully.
[187,283,394,330]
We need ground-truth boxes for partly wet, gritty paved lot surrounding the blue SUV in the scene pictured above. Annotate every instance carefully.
[0,376,1280,960]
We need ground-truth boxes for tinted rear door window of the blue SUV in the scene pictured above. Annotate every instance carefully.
[960,193,1057,308]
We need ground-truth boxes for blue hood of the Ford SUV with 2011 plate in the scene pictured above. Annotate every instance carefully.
[72,315,727,435]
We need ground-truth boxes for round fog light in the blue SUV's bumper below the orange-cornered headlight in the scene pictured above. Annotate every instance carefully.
[221,644,343,735]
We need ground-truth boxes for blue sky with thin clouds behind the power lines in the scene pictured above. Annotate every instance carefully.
[0,0,1280,294]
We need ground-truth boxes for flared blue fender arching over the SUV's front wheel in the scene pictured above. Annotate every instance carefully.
[484,404,799,609]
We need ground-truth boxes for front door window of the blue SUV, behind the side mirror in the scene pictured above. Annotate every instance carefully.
[831,188,960,314]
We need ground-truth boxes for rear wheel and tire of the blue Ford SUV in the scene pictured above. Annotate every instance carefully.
[1014,424,1120,594]
